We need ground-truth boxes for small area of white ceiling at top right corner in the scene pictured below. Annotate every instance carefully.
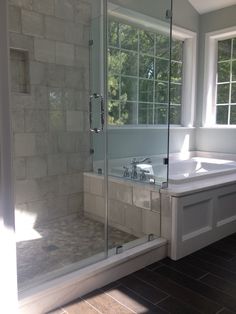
[188,0,236,14]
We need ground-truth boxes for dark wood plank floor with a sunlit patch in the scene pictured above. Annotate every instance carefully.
[48,233,236,314]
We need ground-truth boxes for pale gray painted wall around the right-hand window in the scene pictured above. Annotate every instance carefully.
[196,5,236,153]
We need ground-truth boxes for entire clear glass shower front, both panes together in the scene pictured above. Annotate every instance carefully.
[8,0,171,292]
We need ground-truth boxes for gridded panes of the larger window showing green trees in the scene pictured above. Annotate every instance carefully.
[108,18,184,125]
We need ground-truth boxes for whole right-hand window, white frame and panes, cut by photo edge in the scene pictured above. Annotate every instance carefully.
[202,26,236,127]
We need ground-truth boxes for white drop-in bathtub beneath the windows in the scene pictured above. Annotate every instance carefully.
[94,156,236,184]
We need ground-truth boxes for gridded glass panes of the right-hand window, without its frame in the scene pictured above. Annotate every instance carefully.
[216,37,236,125]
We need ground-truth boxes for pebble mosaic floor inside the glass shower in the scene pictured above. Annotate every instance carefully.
[17,216,136,289]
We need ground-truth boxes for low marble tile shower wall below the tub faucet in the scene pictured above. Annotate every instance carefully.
[83,173,161,237]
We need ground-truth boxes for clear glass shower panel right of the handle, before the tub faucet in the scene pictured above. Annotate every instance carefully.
[107,0,171,254]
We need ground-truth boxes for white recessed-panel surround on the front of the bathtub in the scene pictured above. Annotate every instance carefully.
[161,182,236,260]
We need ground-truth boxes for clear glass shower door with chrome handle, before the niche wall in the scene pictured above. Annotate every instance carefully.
[11,0,106,294]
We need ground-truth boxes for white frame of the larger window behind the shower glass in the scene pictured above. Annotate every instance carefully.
[108,3,197,128]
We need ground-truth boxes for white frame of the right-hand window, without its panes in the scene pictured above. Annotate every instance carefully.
[202,26,236,128]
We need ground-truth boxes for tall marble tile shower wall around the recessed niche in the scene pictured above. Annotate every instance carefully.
[8,0,92,223]
